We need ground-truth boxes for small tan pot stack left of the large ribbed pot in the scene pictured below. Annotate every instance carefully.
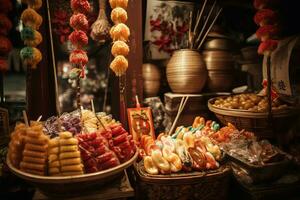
[143,63,161,97]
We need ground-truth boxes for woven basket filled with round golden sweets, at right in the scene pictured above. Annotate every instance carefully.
[208,93,299,138]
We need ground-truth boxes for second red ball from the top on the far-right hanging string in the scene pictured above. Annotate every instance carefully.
[254,9,278,26]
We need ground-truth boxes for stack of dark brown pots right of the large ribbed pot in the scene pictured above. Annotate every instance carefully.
[203,35,235,92]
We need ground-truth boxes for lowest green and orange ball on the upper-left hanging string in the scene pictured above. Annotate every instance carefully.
[20,47,42,69]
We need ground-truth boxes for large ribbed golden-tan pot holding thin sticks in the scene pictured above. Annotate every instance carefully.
[167,49,207,94]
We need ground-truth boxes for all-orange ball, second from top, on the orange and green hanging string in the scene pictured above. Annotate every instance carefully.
[21,8,43,30]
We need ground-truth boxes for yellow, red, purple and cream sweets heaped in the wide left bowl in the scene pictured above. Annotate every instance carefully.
[8,110,136,176]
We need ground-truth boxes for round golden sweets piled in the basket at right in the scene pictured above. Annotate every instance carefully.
[213,93,288,112]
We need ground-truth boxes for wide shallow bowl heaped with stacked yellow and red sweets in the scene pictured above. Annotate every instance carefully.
[6,112,138,197]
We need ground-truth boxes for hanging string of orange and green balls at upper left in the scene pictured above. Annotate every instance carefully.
[20,0,43,69]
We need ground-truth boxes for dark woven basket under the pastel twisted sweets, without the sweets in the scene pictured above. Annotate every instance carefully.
[134,162,231,200]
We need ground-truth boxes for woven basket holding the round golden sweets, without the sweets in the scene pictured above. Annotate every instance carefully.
[208,97,299,139]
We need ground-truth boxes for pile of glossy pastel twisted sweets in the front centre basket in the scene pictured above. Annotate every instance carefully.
[140,118,223,175]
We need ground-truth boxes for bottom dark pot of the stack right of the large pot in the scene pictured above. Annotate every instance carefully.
[207,70,234,92]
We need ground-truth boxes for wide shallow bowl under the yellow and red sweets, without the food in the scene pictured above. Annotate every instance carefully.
[6,151,138,196]
